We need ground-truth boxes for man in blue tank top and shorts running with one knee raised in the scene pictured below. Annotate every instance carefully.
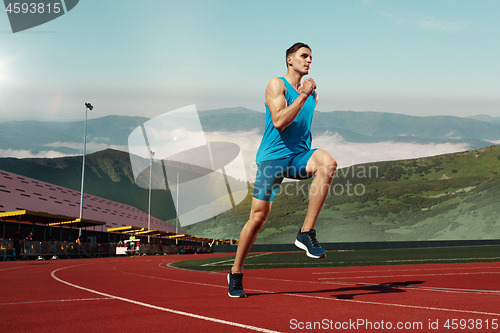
[227,43,337,297]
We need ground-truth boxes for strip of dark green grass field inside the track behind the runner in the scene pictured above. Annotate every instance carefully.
[171,245,500,271]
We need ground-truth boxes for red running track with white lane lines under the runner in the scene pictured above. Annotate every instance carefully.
[0,254,500,332]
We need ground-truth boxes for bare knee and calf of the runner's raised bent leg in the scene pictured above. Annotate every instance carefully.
[301,149,337,232]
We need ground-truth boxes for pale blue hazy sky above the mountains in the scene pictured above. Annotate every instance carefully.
[0,0,500,120]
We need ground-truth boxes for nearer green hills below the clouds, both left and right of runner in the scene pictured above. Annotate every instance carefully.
[0,145,500,244]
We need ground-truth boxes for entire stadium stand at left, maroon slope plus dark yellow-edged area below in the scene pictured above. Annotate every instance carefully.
[0,170,237,260]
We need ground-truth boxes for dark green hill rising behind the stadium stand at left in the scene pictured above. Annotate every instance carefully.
[0,149,176,220]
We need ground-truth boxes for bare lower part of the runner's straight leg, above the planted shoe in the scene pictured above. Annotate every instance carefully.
[231,198,272,273]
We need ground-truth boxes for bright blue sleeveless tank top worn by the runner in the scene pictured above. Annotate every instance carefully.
[256,77,316,163]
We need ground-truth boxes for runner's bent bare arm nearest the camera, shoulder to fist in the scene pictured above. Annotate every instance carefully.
[266,78,314,131]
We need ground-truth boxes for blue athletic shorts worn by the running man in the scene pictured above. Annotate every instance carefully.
[253,149,316,201]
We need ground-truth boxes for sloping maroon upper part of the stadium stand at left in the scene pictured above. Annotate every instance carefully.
[0,170,184,234]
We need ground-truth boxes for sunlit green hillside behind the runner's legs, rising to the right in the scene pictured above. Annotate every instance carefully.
[184,146,500,244]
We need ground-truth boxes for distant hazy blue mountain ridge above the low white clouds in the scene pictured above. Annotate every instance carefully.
[0,107,500,156]
